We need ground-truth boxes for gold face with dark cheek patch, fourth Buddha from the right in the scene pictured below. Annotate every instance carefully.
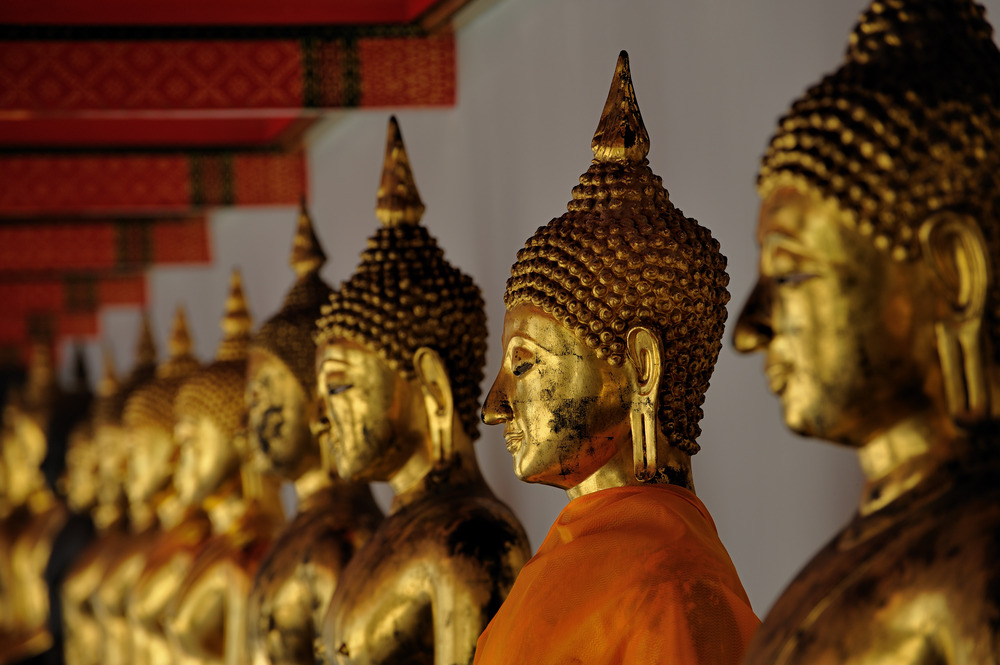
[246,348,314,478]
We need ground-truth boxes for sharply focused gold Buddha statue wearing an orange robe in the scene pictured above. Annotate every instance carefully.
[476,51,758,664]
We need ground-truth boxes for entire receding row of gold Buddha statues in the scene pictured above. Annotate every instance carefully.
[0,0,1000,665]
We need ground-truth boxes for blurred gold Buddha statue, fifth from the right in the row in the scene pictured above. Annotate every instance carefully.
[166,272,284,665]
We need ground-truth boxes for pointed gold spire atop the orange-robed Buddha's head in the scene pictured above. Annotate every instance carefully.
[590,51,649,162]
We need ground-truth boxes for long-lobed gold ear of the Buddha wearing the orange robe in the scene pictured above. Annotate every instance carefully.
[625,326,663,481]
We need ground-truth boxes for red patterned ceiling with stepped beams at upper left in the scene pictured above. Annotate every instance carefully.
[0,0,469,365]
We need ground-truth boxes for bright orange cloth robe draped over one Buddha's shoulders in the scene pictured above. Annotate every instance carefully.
[475,485,760,665]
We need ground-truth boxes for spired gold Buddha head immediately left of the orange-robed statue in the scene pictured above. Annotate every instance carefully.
[317,118,486,481]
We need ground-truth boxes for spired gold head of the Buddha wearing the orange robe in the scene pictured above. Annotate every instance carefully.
[483,51,729,490]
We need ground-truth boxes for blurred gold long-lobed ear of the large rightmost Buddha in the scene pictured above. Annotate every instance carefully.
[920,212,992,423]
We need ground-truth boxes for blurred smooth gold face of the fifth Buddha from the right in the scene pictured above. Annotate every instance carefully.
[174,412,240,506]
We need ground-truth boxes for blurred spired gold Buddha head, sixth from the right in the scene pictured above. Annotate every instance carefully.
[122,308,198,510]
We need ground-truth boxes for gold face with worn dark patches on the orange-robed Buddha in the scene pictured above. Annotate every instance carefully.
[483,304,633,489]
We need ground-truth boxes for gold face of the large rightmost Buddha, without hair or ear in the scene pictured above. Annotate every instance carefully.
[735,188,936,446]
